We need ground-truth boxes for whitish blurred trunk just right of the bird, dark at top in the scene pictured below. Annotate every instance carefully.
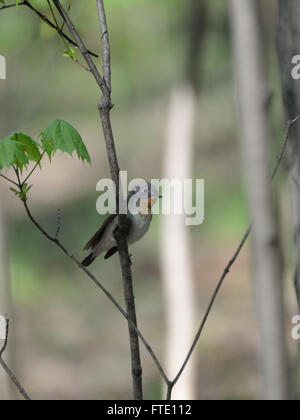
[161,0,206,400]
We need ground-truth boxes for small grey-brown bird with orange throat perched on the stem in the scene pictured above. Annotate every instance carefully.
[81,182,161,267]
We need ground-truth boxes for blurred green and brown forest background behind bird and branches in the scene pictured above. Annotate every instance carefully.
[0,0,297,399]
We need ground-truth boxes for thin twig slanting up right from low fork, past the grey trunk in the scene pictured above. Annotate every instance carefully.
[167,116,299,400]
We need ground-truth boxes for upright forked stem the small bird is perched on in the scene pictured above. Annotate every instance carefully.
[53,0,143,400]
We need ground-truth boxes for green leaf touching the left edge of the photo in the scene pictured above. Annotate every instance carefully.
[0,133,41,170]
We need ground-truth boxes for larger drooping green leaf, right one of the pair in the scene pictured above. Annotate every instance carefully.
[41,119,91,163]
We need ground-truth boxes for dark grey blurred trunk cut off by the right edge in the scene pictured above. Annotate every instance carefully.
[277,0,300,309]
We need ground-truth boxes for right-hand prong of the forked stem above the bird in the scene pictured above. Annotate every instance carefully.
[97,0,111,91]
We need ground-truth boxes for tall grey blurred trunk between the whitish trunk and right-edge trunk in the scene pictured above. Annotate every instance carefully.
[231,0,289,400]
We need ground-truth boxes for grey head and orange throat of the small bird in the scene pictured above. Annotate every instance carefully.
[128,181,161,214]
